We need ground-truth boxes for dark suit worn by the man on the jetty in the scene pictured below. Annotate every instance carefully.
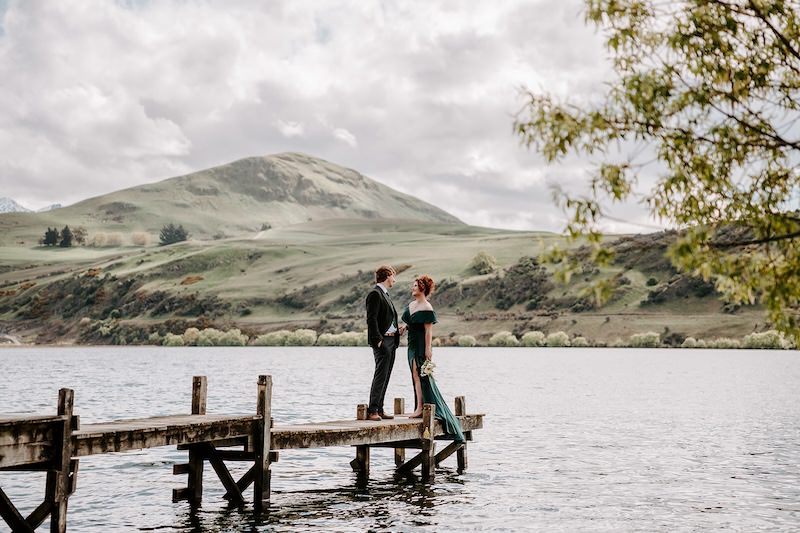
[367,285,399,413]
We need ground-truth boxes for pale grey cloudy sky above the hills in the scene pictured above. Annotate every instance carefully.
[0,0,664,231]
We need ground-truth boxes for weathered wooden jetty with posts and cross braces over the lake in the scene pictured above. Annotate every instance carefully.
[0,376,483,533]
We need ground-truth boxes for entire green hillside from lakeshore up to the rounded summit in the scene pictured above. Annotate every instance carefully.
[0,153,768,344]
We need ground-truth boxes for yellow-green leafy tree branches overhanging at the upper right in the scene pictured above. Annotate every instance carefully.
[515,0,800,337]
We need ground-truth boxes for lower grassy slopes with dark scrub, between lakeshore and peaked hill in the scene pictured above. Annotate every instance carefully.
[0,219,766,343]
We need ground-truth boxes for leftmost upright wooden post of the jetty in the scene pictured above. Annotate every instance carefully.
[46,389,78,533]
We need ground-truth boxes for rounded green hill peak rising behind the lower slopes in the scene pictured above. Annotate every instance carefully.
[0,153,460,246]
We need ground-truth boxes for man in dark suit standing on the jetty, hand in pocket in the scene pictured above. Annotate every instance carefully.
[367,265,404,421]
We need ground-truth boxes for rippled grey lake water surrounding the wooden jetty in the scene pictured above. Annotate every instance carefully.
[0,347,800,532]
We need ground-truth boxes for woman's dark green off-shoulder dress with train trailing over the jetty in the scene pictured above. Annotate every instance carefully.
[402,306,464,442]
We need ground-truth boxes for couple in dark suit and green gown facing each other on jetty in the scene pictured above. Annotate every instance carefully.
[367,265,464,442]
